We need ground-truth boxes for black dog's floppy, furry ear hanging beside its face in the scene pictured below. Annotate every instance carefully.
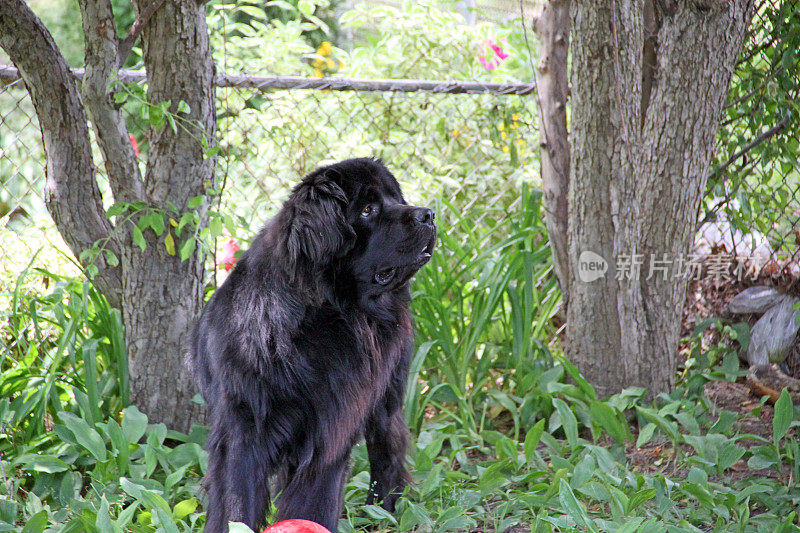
[286,171,355,265]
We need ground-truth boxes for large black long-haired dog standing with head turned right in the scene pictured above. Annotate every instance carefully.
[190,159,436,533]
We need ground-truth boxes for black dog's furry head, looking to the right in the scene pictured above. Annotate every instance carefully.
[284,159,436,300]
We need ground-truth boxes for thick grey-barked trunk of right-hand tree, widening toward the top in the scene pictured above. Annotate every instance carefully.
[567,0,752,395]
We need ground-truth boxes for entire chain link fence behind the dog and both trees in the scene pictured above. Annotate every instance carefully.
[0,0,800,332]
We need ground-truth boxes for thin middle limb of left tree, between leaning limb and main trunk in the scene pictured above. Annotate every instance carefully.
[79,0,145,202]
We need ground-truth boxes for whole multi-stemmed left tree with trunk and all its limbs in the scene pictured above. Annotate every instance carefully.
[0,0,215,430]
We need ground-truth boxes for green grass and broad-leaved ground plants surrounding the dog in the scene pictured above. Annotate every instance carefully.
[0,193,800,533]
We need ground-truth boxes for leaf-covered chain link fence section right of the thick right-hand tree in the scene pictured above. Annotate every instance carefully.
[696,0,800,279]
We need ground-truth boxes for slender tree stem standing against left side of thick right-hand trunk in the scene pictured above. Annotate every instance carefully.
[533,0,570,308]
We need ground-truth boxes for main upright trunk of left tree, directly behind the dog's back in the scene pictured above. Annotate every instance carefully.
[121,0,215,430]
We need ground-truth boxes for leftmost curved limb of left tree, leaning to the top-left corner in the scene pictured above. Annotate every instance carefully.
[0,0,122,306]
